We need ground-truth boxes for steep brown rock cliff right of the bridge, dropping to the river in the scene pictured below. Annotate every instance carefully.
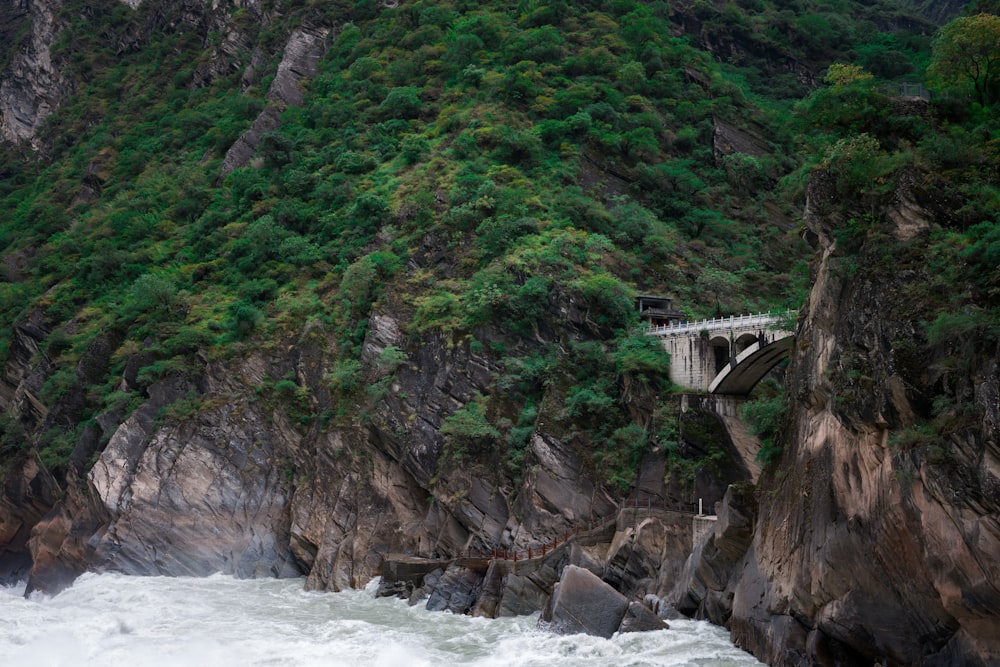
[678,177,1000,665]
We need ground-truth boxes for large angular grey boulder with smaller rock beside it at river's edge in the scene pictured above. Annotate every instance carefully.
[541,565,667,639]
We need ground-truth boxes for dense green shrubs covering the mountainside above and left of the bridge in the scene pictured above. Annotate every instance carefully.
[0,0,989,490]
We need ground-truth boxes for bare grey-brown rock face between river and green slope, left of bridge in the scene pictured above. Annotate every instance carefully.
[0,234,752,600]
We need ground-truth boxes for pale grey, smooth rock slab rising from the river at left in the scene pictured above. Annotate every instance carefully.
[90,396,301,577]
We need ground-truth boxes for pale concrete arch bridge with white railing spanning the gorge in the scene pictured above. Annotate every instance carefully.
[648,312,794,396]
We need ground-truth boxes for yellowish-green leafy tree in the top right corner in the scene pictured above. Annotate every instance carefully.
[928,14,1000,106]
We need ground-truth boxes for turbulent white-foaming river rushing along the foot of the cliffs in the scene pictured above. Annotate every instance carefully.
[0,574,761,667]
